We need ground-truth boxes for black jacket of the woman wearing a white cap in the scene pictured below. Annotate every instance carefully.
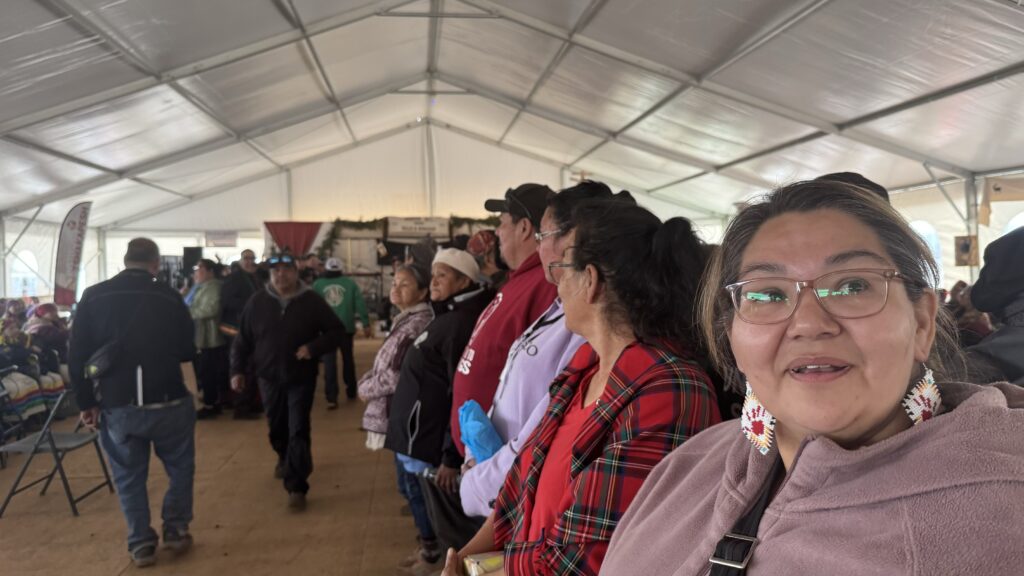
[384,288,495,467]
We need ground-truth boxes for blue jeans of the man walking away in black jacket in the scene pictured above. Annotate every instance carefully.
[99,396,196,551]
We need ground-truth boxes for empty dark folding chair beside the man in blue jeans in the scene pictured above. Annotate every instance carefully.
[0,390,114,518]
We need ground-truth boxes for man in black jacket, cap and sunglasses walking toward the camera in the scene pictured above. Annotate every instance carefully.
[231,254,345,510]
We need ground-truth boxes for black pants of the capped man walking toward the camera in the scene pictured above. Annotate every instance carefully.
[259,378,316,494]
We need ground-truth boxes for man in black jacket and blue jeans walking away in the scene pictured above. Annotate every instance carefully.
[70,238,196,567]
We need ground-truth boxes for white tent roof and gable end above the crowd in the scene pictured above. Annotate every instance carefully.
[0,0,1024,235]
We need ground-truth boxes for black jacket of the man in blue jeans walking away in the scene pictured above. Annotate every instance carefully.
[68,269,196,410]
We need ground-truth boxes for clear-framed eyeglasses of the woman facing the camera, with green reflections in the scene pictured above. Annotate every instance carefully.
[725,269,920,324]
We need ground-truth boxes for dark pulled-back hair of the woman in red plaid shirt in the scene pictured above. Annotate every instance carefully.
[572,200,708,353]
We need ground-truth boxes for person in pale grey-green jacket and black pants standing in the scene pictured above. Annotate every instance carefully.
[188,258,228,420]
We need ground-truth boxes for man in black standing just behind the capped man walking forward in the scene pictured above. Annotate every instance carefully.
[220,250,263,419]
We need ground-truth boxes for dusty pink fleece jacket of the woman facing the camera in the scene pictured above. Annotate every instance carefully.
[601,383,1024,576]
